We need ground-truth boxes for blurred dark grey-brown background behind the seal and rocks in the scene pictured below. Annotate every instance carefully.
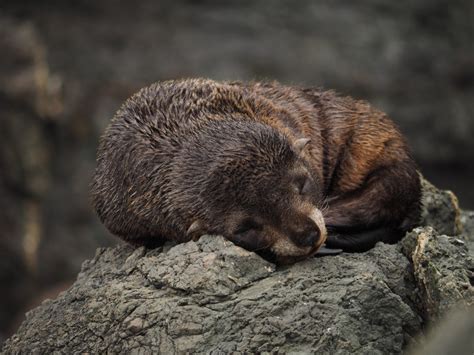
[0,0,474,342]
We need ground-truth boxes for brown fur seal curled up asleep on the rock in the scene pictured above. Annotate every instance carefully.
[92,79,421,263]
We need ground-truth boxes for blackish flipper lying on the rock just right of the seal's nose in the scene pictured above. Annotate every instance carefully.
[326,228,404,252]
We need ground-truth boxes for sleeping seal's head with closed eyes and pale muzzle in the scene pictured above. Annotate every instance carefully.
[183,123,326,264]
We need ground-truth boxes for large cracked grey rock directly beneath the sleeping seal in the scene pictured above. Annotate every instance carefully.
[3,236,421,354]
